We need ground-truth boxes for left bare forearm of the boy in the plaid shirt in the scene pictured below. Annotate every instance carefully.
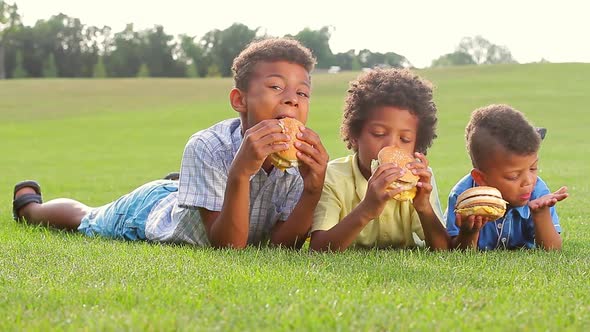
[209,172,250,248]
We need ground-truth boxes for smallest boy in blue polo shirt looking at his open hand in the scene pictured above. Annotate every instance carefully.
[445,105,568,250]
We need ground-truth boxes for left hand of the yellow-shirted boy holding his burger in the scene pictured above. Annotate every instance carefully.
[360,163,405,219]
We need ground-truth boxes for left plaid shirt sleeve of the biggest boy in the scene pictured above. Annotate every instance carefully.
[178,136,227,211]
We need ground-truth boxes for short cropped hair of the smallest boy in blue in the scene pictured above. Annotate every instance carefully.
[465,104,541,168]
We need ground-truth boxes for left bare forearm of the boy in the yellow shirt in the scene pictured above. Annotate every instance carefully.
[311,204,373,251]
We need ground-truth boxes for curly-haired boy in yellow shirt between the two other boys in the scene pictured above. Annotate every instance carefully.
[311,69,449,251]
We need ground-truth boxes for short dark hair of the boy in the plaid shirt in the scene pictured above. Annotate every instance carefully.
[231,38,316,91]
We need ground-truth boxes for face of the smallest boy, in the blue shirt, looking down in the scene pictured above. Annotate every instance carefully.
[472,149,539,206]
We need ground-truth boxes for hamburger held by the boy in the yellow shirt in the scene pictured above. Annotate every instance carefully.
[371,146,420,201]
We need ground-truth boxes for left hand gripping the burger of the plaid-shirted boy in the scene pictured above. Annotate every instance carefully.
[232,119,289,176]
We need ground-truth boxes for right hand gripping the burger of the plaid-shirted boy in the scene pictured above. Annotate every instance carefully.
[295,127,330,194]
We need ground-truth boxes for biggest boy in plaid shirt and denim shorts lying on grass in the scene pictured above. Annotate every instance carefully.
[13,39,328,248]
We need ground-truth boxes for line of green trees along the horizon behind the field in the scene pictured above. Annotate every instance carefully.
[0,0,514,79]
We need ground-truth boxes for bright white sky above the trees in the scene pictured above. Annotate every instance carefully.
[10,0,590,67]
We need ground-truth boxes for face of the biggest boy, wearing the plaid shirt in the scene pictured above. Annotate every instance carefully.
[234,61,311,130]
